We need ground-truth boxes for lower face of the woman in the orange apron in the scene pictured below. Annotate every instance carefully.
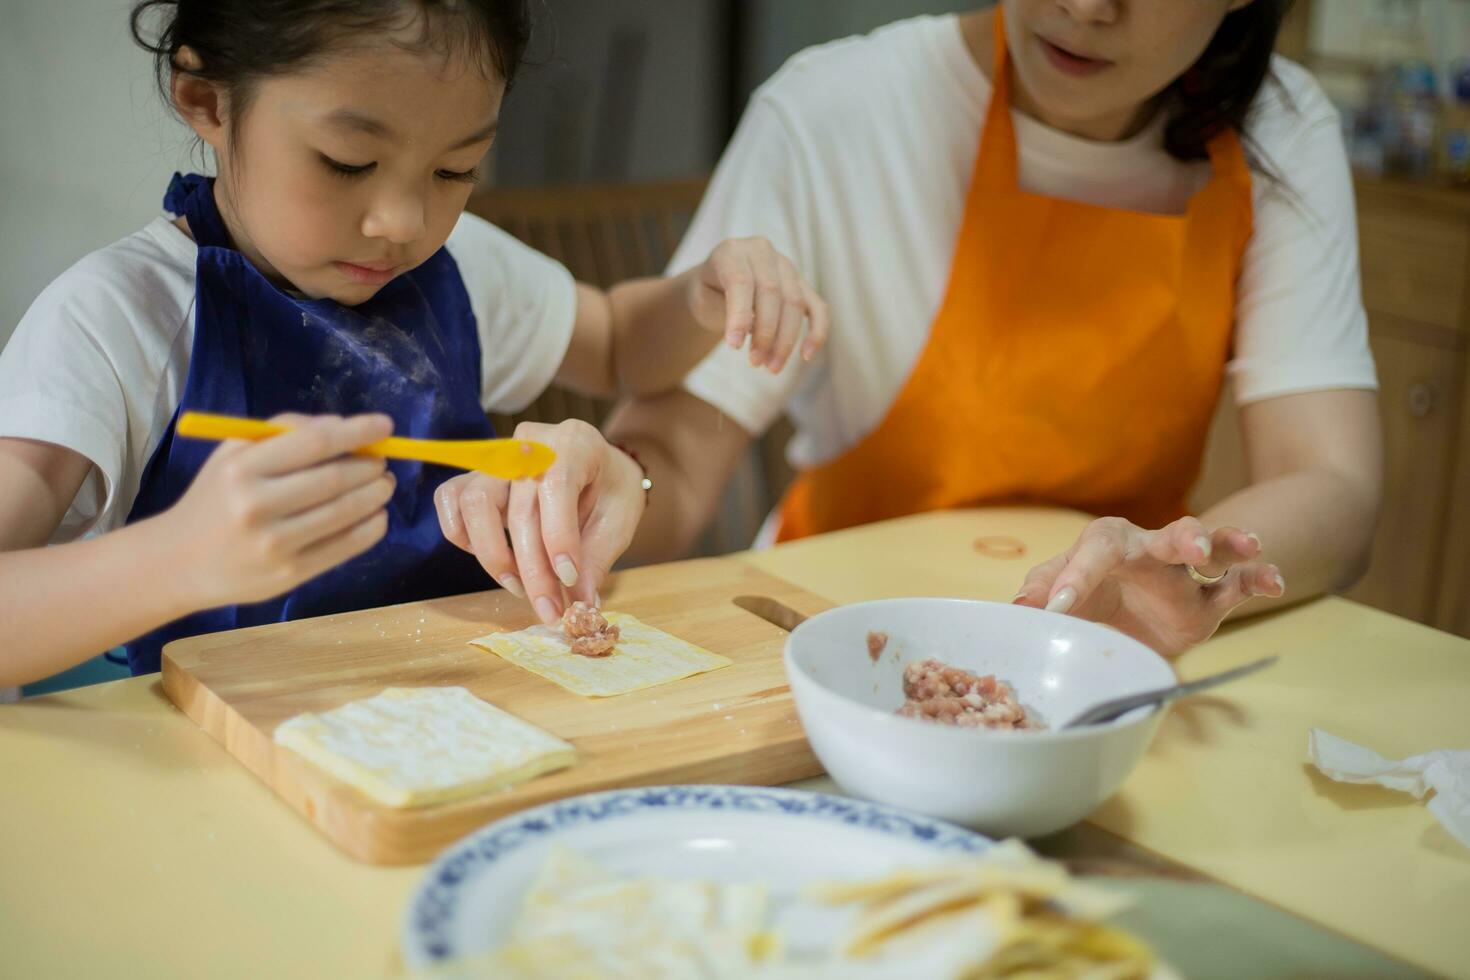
[1003,0,1251,140]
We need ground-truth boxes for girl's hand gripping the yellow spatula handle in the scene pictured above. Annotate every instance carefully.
[159,414,394,608]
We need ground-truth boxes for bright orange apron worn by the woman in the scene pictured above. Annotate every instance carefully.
[778,12,1251,541]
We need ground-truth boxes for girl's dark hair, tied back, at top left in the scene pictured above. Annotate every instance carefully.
[131,0,531,125]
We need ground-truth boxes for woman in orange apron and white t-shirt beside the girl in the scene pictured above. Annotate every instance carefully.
[596,0,1380,652]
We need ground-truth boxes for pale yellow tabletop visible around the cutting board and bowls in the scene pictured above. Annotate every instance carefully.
[0,510,1470,977]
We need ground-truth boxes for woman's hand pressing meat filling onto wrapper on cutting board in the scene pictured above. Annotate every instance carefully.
[434,419,644,626]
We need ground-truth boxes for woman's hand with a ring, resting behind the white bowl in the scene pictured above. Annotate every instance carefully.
[1014,517,1286,657]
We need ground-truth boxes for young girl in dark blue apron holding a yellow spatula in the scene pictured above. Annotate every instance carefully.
[0,0,826,686]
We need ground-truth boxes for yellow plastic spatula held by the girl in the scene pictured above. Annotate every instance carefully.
[176,411,556,480]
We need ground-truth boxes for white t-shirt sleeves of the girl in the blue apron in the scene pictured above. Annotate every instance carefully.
[0,215,576,542]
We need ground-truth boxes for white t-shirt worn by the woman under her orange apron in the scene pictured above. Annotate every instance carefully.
[669,16,1376,467]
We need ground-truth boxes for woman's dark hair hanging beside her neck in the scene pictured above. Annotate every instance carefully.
[1164,0,1291,160]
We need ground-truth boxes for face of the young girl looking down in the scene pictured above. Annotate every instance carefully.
[196,37,506,304]
